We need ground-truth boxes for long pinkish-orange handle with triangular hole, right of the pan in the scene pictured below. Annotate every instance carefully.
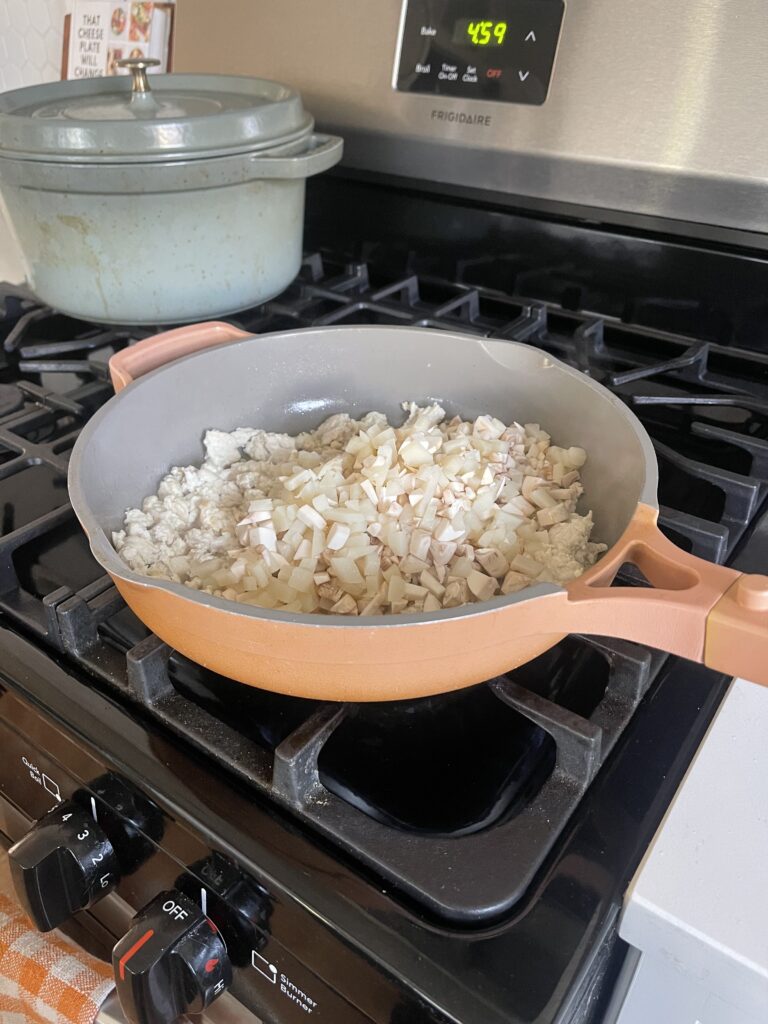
[561,504,768,686]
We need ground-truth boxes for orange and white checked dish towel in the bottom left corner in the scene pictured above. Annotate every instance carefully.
[0,892,115,1024]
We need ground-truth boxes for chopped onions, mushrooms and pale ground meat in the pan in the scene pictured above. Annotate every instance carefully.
[113,403,606,615]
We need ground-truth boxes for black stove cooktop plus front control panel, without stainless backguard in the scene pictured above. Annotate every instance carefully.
[0,169,768,1024]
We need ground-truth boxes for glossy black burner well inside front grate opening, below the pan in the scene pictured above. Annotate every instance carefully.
[318,686,555,837]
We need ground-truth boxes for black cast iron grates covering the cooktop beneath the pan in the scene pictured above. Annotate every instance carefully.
[0,253,768,923]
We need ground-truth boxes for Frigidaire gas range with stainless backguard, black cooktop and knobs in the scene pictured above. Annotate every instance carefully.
[0,0,768,1011]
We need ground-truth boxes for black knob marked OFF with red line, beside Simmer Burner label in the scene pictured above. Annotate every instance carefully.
[112,890,232,1024]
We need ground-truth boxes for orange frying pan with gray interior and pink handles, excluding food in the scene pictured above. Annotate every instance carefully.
[69,323,768,700]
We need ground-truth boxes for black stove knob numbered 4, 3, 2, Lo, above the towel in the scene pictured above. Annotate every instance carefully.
[8,801,120,932]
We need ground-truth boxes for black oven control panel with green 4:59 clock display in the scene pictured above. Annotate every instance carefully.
[394,0,565,104]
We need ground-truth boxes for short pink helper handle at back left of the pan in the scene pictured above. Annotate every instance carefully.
[110,321,251,394]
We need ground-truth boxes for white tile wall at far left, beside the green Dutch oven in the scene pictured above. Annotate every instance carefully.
[0,0,70,281]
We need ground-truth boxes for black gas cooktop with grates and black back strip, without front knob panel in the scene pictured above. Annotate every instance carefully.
[0,180,768,1024]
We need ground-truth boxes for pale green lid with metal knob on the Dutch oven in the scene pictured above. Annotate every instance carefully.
[0,64,312,163]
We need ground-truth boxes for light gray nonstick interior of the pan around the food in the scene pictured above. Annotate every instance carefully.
[69,327,657,626]
